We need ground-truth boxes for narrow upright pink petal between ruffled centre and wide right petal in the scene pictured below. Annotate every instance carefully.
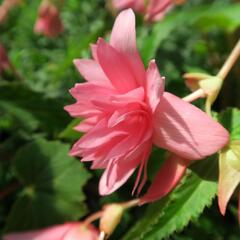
[146,60,164,112]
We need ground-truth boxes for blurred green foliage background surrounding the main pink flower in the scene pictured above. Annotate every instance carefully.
[0,0,240,240]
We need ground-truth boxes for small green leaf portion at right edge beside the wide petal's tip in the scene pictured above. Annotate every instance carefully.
[218,108,240,141]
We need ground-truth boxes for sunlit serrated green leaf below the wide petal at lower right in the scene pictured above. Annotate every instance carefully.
[123,158,217,240]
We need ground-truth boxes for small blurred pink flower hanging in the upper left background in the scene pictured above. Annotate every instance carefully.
[34,0,63,37]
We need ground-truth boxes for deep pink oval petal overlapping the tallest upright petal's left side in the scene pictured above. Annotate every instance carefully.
[97,39,137,93]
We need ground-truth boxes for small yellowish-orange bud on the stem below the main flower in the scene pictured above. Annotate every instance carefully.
[100,204,124,236]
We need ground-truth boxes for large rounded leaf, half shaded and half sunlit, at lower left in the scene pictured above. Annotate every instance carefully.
[5,139,89,232]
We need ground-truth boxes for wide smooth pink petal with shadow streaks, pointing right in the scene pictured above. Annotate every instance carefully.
[153,92,229,160]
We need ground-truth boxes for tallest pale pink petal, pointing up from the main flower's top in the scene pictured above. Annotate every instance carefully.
[110,9,145,86]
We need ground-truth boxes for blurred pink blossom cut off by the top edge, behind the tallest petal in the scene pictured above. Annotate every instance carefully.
[112,0,185,22]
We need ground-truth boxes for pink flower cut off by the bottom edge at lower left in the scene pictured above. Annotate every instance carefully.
[3,222,99,240]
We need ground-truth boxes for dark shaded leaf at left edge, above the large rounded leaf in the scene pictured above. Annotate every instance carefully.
[0,83,69,132]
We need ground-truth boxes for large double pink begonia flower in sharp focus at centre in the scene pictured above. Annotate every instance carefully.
[65,10,229,200]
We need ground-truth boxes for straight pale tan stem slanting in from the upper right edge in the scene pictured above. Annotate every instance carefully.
[217,39,240,79]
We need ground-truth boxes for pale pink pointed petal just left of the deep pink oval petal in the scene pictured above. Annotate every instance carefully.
[73,59,111,87]
